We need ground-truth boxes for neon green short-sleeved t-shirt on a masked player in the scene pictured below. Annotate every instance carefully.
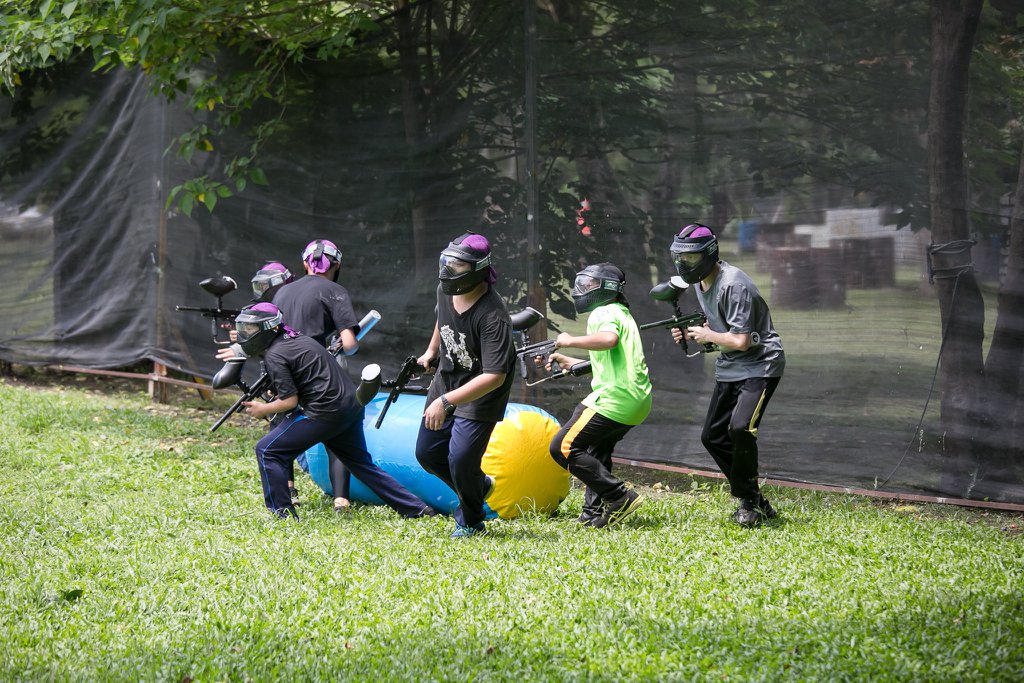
[583,302,651,425]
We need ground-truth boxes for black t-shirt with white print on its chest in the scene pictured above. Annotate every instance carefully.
[427,287,515,422]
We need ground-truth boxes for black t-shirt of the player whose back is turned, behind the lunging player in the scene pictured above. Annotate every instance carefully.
[273,275,359,346]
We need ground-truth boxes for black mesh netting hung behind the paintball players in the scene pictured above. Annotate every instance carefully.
[0,2,1024,502]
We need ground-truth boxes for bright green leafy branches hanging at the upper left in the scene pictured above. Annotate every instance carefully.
[0,0,377,213]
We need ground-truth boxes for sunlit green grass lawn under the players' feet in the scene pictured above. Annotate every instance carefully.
[0,377,1024,683]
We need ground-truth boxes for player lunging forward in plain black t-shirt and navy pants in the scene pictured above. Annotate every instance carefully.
[234,302,434,517]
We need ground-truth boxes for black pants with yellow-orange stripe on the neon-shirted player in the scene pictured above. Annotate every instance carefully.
[549,403,633,515]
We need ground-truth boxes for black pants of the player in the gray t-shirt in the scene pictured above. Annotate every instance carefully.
[700,377,781,498]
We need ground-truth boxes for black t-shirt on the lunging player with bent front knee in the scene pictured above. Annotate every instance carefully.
[263,335,359,419]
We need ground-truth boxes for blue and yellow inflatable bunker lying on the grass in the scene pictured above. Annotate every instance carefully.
[305,392,569,519]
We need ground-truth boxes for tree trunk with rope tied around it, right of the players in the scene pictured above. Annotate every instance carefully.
[928,0,984,497]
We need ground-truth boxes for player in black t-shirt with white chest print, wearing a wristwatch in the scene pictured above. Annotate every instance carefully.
[416,232,515,539]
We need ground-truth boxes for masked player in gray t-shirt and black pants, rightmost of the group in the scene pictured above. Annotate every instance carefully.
[671,223,785,526]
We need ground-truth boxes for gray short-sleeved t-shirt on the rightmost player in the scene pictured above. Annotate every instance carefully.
[695,261,785,382]
